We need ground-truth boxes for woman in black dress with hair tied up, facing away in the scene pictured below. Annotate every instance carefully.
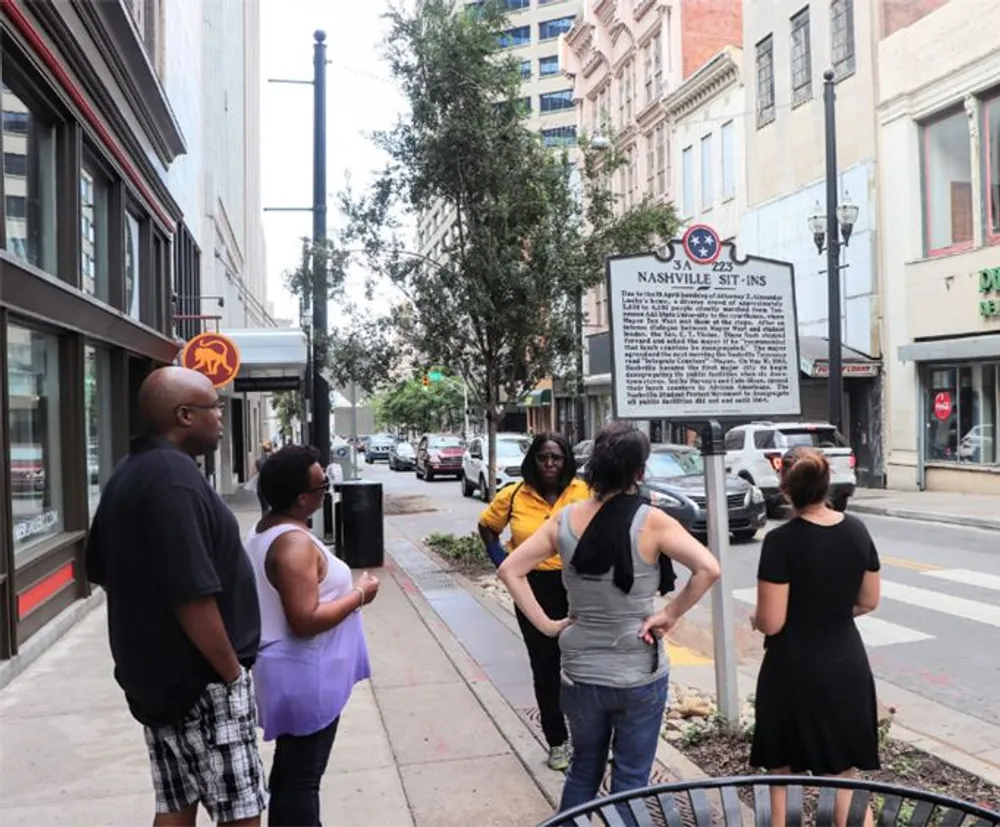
[750,448,880,825]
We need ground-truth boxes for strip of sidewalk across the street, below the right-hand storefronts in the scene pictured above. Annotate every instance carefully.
[849,488,1000,531]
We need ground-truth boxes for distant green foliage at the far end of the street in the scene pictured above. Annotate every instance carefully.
[373,377,464,434]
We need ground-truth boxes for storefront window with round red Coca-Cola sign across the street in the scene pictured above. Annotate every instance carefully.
[926,363,1000,465]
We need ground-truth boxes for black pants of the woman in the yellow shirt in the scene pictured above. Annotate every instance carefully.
[515,571,569,747]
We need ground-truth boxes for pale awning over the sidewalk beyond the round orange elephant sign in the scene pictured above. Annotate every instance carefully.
[220,327,308,393]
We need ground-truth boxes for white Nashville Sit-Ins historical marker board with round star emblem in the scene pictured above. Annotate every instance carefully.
[607,231,801,422]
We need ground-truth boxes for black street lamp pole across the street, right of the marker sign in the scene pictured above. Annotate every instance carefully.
[823,69,844,431]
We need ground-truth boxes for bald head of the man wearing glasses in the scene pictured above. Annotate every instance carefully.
[139,366,222,453]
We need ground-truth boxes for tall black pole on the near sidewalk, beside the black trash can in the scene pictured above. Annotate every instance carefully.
[312,30,333,537]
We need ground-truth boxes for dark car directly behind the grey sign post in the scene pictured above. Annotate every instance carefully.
[643,444,767,541]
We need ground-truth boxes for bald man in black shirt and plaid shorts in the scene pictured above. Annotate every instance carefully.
[87,367,267,827]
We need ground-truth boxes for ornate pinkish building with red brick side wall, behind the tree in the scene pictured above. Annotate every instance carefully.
[555,0,743,440]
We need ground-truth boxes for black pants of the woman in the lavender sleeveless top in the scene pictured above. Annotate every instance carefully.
[267,718,340,827]
